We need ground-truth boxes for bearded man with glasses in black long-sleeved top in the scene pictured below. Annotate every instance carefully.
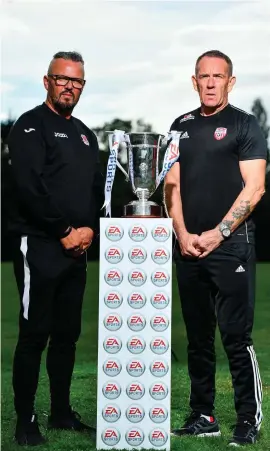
[8,52,103,445]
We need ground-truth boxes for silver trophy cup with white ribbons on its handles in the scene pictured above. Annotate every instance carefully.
[105,130,181,217]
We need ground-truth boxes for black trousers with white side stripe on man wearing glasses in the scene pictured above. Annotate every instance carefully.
[13,236,86,417]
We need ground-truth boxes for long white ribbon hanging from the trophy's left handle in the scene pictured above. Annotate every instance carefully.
[102,130,128,217]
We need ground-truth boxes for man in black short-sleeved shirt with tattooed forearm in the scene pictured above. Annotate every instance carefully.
[164,50,267,446]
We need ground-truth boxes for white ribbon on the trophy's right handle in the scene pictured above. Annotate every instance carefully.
[156,130,181,188]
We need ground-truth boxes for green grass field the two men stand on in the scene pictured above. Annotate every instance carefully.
[2,263,270,451]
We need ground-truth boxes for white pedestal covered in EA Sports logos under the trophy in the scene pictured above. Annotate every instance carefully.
[96,217,173,451]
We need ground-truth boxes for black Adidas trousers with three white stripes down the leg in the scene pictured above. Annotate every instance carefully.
[175,241,262,425]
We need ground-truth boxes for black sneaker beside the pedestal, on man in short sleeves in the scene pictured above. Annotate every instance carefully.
[171,412,221,437]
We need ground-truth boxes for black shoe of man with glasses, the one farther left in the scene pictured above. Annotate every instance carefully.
[15,415,46,446]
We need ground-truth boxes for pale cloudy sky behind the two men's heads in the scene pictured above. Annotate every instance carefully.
[0,0,270,133]
